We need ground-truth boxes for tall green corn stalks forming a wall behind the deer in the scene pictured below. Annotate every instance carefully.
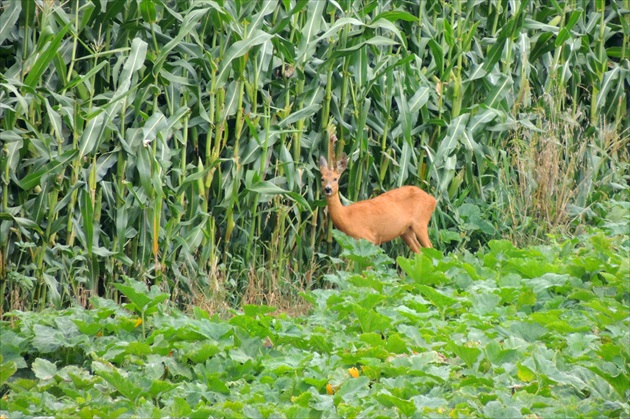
[0,0,630,310]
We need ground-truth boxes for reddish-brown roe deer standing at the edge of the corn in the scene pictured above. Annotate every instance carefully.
[319,153,436,253]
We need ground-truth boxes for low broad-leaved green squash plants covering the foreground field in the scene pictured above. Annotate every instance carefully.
[0,232,630,418]
